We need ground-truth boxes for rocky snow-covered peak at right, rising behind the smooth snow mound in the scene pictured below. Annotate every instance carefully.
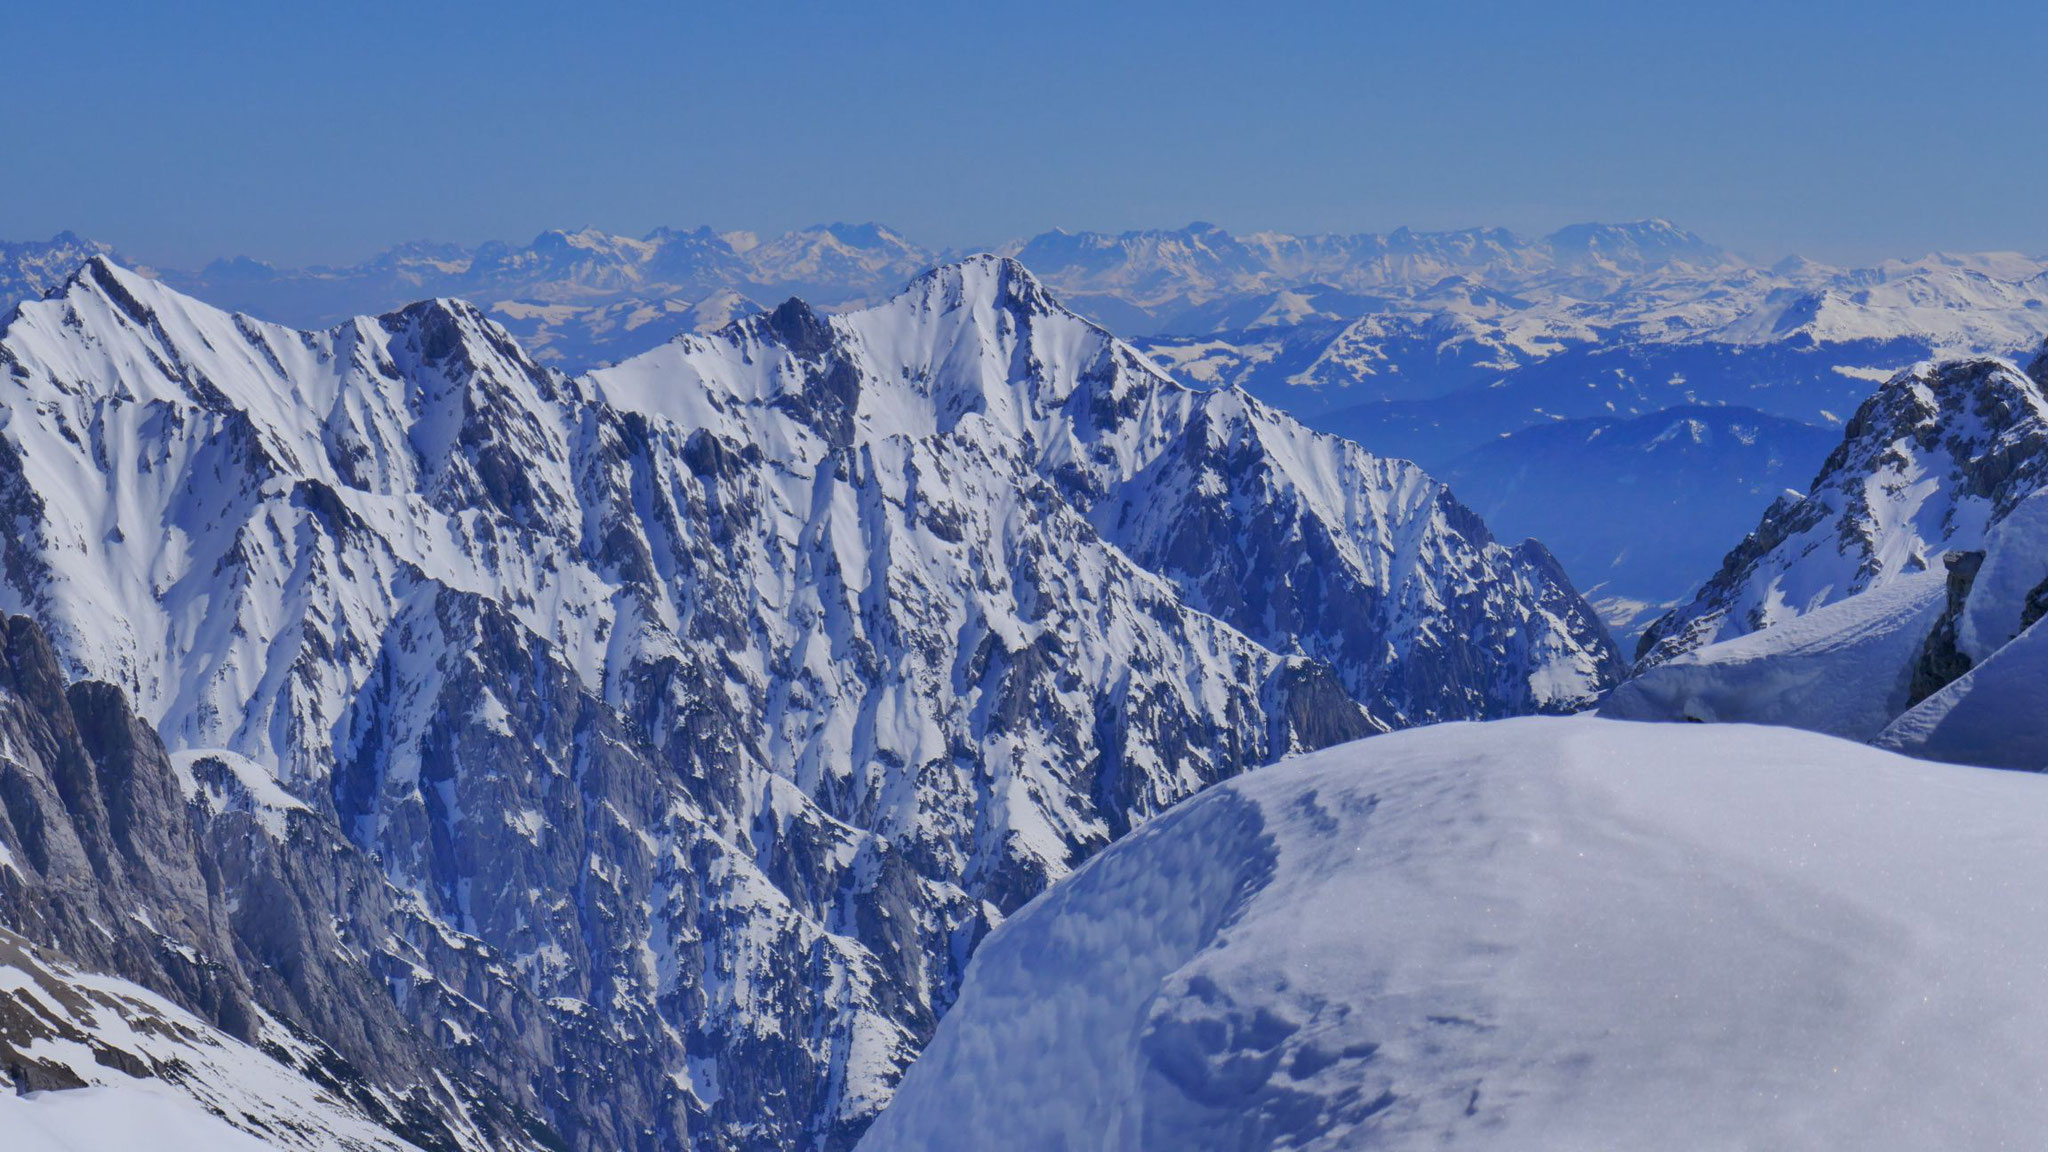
[1604,340,2048,754]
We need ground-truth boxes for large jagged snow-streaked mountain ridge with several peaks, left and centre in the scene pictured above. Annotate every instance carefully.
[0,256,1620,1150]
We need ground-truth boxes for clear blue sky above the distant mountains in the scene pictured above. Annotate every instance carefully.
[16,0,2048,262]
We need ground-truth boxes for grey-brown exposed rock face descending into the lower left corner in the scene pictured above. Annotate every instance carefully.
[0,617,549,1150]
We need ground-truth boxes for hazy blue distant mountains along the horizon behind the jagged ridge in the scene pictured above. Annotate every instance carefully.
[0,219,2048,629]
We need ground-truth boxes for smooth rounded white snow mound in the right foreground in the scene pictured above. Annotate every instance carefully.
[860,717,2048,1152]
